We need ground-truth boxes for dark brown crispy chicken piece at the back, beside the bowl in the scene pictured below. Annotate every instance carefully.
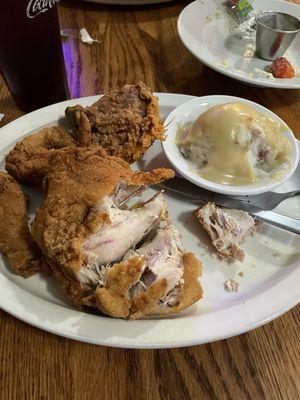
[65,82,164,163]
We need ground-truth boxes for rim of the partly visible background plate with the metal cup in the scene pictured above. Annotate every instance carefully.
[177,0,300,90]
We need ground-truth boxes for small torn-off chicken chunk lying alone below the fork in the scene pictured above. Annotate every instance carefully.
[194,203,257,262]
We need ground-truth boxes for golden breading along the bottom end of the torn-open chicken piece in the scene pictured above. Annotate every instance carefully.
[95,253,203,320]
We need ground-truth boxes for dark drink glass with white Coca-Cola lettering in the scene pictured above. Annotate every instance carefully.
[0,0,68,111]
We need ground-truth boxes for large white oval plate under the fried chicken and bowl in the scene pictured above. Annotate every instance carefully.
[0,94,300,348]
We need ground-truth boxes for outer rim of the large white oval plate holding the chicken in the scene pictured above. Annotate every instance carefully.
[0,93,300,349]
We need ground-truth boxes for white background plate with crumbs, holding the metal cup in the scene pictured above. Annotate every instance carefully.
[177,0,300,89]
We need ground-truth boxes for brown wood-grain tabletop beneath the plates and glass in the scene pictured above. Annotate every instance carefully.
[0,0,300,400]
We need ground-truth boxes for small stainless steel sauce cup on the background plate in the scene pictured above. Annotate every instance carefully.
[256,12,300,60]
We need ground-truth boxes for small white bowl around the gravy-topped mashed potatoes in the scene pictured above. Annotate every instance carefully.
[162,95,299,195]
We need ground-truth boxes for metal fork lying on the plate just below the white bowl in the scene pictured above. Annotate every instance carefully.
[156,177,300,210]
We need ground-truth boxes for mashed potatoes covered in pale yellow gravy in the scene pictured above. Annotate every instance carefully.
[176,103,291,185]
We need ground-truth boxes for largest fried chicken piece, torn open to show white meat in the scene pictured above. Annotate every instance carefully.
[33,146,202,319]
